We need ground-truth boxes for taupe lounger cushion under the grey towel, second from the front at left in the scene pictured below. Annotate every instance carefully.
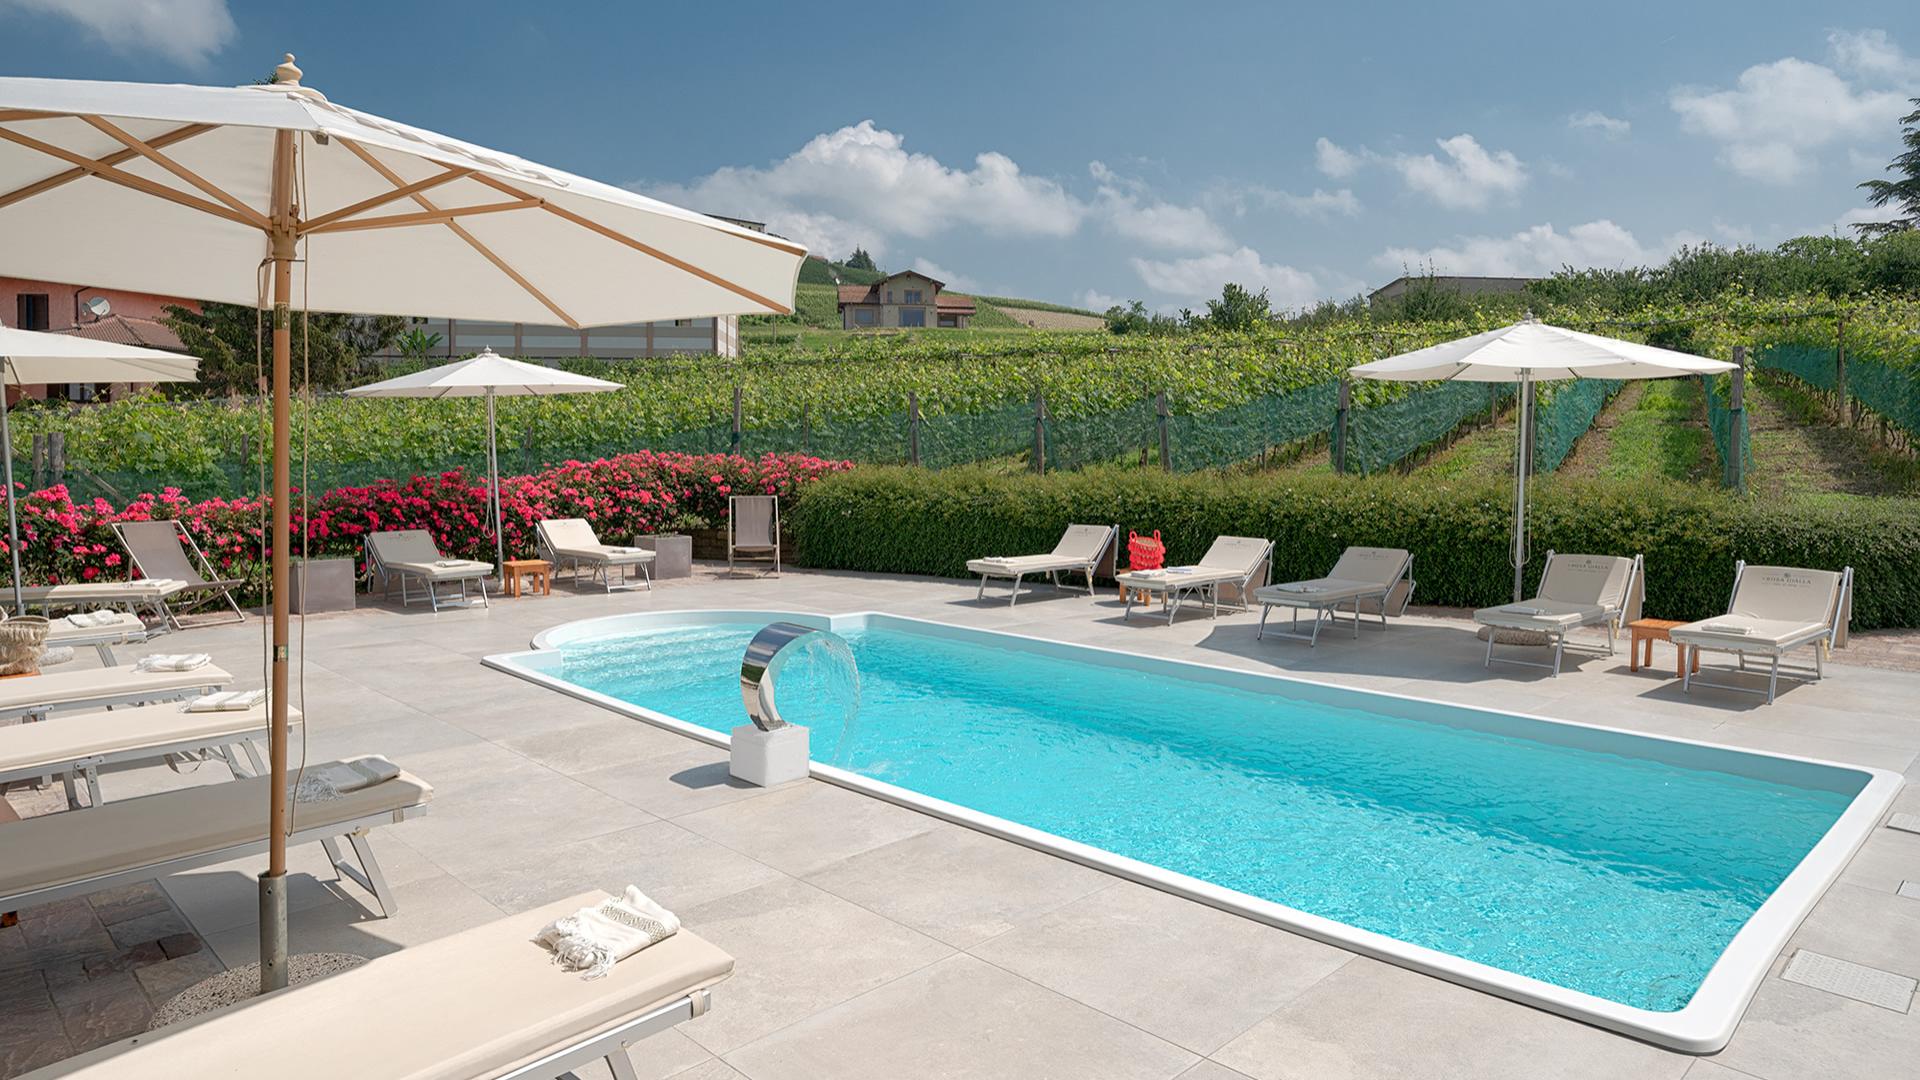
[0,760,434,896]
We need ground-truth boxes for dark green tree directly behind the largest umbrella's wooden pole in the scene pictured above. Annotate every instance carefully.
[161,302,407,394]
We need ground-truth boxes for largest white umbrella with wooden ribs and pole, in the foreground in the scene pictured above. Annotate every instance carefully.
[0,56,806,990]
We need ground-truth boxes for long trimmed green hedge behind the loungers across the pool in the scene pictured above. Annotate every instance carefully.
[789,467,1920,628]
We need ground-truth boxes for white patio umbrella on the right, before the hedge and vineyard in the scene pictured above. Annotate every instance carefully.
[1348,315,1736,600]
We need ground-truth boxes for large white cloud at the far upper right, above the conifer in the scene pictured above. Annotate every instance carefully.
[1668,31,1920,184]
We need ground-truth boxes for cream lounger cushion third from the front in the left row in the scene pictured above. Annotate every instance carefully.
[0,703,286,776]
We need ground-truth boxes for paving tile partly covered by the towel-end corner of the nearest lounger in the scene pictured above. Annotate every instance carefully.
[678,878,952,1055]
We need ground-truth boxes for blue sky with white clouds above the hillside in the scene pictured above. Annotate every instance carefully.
[0,0,1920,309]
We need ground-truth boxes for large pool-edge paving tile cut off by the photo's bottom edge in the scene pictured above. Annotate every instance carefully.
[1212,957,1693,1080]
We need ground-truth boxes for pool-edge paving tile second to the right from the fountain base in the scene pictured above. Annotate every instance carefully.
[806,824,1116,949]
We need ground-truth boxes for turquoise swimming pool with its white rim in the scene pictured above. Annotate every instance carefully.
[488,611,1899,1051]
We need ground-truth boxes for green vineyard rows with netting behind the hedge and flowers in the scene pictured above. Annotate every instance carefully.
[13,294,1920,498]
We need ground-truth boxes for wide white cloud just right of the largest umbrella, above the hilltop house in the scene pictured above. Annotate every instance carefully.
[649,119,1087,254]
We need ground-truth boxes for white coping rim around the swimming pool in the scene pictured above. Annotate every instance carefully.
[484,609,1903,1053]
